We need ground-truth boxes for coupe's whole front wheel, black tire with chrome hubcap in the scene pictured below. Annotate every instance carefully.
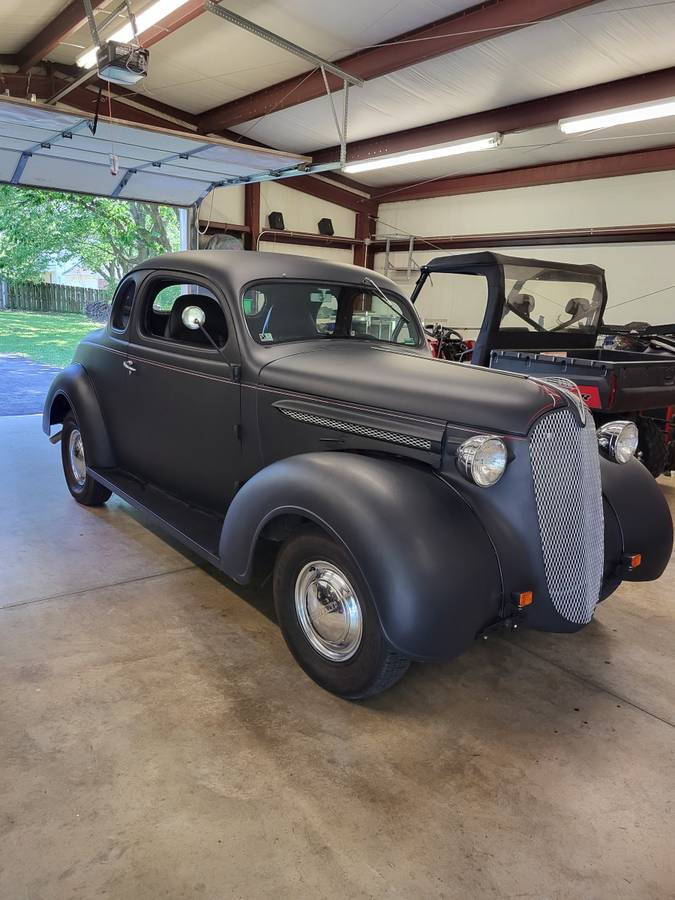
[274,531,410,700]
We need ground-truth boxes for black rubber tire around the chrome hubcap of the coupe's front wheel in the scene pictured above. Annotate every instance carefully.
[274,529,410,700]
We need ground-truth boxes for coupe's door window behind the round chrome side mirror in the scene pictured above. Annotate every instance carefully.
[142,278,227,348]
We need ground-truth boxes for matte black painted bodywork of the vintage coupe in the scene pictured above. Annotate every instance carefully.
[43,251,672,659]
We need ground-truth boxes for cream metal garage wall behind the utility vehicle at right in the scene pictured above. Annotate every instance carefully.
[375,172,675,326]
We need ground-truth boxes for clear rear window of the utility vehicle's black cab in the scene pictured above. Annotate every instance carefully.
[500,264,603,332]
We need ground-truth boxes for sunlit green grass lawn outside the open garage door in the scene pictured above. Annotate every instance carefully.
[0,309,101,367]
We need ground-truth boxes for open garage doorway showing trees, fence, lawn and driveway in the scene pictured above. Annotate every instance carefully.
[0,185,185,416]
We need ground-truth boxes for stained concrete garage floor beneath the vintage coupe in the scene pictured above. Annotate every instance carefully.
[0,417,675,900]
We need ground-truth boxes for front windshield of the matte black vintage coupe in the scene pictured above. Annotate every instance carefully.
[242,279,420,347]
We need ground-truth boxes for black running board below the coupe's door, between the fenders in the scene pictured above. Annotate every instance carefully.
[87,468,224,566]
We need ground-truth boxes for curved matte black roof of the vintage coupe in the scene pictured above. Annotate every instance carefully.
[133,250,401,295]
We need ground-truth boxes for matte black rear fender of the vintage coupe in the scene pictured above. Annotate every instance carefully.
[42,363,115,469]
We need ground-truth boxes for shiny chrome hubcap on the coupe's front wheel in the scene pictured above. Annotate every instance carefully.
[295,560,363,662]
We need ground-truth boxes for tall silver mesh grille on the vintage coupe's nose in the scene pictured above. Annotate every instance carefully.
[530,409,604,624]
